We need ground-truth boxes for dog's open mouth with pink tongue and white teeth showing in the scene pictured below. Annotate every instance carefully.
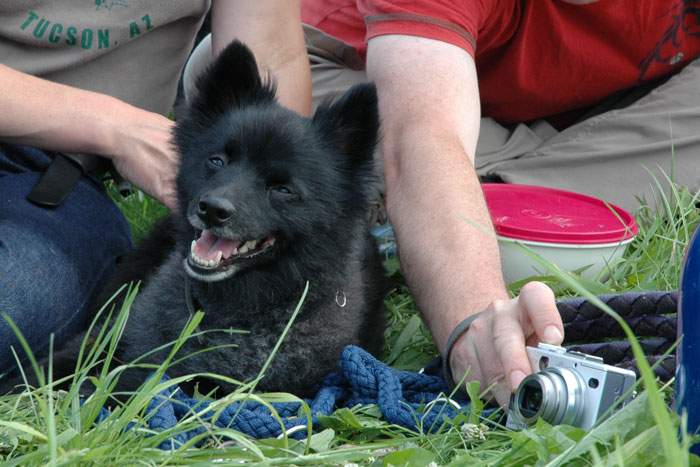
[185,230,275,282]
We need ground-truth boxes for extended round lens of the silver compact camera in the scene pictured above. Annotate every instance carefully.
[514,367,586,425]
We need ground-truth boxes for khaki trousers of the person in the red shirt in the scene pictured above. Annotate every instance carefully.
[184,26,700,209]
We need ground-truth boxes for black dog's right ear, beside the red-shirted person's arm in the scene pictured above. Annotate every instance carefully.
[313,83,379,167]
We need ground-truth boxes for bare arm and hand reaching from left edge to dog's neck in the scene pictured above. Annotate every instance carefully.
[0,64,177,207]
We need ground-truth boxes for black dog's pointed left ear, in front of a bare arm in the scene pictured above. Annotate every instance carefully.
[191,41,275,115]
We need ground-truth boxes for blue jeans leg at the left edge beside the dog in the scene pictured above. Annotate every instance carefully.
[0,145,131,374]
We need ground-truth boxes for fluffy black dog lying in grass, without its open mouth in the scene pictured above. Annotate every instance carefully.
[0,43,386,396]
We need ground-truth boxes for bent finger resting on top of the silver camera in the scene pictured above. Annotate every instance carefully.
[518,282,564,345]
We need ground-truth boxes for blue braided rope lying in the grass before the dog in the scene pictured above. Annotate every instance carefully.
[98,345,469,449]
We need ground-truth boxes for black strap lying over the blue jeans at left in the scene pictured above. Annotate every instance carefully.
[27,153,109,208]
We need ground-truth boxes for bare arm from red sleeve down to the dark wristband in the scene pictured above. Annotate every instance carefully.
[368,37,507,350]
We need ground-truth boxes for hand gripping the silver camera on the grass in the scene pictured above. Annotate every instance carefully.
[449,282,564,407]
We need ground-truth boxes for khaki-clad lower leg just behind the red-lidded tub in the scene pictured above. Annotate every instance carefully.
[489,60,700,209]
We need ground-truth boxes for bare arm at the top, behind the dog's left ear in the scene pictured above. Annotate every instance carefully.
[212,0,311,115]
